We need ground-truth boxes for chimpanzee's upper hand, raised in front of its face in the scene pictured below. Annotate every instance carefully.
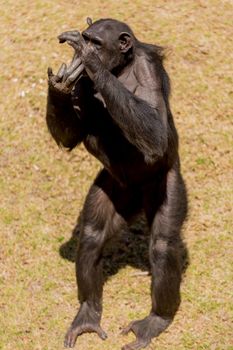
[58,30,103,80]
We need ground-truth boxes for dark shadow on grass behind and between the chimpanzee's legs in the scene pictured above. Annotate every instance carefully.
[60,213,189,281]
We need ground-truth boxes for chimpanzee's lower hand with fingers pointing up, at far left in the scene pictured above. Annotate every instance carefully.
[48,55,84,94]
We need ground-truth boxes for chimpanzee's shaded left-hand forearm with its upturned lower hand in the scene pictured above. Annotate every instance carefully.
[46,60,85,150]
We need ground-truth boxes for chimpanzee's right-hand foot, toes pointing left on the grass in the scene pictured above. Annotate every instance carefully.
[122,314,172,350]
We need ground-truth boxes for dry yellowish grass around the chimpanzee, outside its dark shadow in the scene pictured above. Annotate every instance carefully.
[0,0,233,350]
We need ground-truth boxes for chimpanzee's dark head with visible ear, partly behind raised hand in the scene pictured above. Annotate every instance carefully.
[82,18,136,71]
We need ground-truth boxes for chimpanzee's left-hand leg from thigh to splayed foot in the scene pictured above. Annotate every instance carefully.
[64,170,138,347]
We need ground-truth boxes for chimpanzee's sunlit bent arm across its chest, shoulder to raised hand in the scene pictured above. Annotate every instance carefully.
[59,31,168,162]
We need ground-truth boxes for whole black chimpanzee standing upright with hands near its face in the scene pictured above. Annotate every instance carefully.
[46,19,187,350]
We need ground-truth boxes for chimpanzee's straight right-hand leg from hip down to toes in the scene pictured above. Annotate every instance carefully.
[123,169,187,350]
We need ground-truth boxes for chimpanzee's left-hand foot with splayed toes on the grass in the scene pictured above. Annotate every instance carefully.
[64,303,107,348]
